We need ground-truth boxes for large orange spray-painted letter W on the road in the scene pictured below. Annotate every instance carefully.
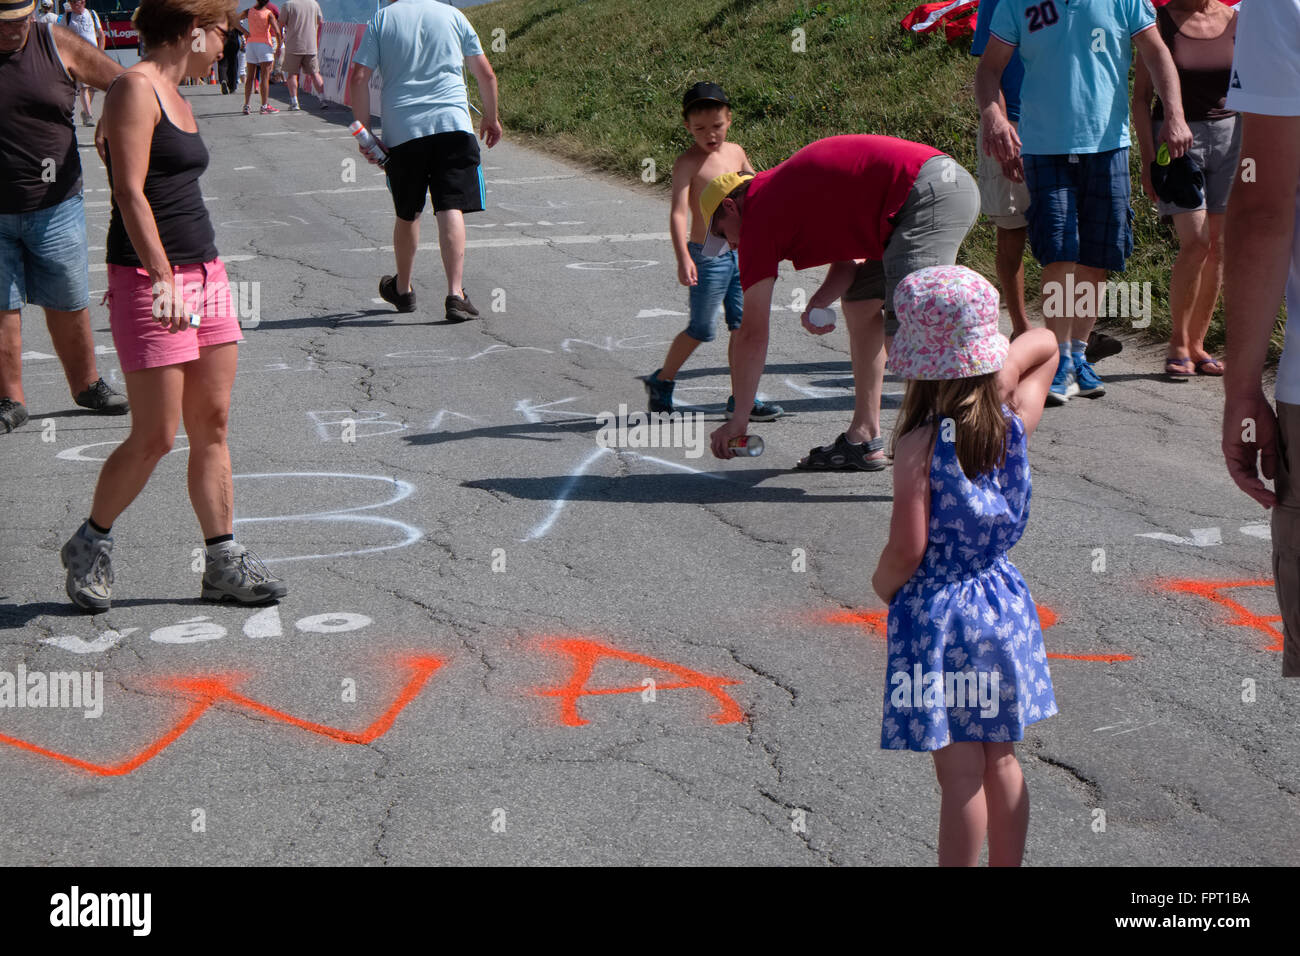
[0,657,445,777]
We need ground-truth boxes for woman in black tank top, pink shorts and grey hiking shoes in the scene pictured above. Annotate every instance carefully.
[61,0,287,611]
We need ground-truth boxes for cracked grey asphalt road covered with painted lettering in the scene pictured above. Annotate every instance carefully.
[0,88,1300,866]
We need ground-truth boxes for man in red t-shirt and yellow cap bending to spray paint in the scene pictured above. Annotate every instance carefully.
[699,135,979,471]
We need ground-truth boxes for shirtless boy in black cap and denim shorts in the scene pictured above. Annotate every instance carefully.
[642,83,784,421]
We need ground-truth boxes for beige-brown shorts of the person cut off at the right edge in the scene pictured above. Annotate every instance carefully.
[1273,402,1300,678]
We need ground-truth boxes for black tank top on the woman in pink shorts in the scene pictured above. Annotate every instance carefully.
[104,81,217,268]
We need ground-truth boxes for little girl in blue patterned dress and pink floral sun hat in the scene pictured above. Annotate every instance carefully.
[871,265,1060,866]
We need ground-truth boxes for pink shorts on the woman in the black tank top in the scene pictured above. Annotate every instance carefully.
[105,259,243,372]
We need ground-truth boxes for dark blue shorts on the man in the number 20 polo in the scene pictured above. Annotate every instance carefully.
[1023,147,1134,272]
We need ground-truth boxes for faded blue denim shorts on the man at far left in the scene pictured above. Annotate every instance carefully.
[0,193,90,312]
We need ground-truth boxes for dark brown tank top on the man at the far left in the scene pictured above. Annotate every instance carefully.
[0,21,82,213]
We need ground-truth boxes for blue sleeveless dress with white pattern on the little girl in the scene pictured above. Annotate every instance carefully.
[880,406,1057,750]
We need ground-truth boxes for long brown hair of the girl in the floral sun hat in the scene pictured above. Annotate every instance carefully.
[889,372,1006,481]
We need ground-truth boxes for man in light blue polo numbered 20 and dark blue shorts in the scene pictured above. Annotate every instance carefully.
[975,0,1192,405]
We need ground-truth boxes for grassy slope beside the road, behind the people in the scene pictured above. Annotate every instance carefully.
[465,0,1282,349]
